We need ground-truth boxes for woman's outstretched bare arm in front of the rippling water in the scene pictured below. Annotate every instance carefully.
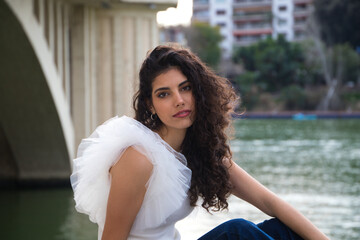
[225,161,328,240]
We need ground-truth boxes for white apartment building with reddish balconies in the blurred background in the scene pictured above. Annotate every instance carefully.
[192,0,313,58]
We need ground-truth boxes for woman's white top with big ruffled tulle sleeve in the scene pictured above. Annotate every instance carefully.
[70,116,193,240]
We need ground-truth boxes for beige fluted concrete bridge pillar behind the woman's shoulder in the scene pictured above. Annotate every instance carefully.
[70,3,169,144]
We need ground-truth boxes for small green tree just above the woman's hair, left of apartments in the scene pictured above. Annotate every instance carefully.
[185,22,222,69]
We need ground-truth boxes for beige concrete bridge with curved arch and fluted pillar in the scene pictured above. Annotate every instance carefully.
[0,0,177,186]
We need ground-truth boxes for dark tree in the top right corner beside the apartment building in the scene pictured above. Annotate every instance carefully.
[314,0,360,48]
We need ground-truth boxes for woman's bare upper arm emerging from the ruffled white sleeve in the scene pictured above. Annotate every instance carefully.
[101,147,153,240]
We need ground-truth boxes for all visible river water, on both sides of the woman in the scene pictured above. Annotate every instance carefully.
[0,119,360,240]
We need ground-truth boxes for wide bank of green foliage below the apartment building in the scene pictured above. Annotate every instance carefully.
[233,32,360,110]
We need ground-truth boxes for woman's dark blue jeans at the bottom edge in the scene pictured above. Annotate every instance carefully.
[198,218,302,240]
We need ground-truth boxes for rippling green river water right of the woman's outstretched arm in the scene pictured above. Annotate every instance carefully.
[232,120,360,240]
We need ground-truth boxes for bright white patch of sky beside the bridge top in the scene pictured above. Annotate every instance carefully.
[157,0,193,26]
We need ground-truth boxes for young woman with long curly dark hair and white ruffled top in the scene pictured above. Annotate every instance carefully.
[71,46,328,240]
